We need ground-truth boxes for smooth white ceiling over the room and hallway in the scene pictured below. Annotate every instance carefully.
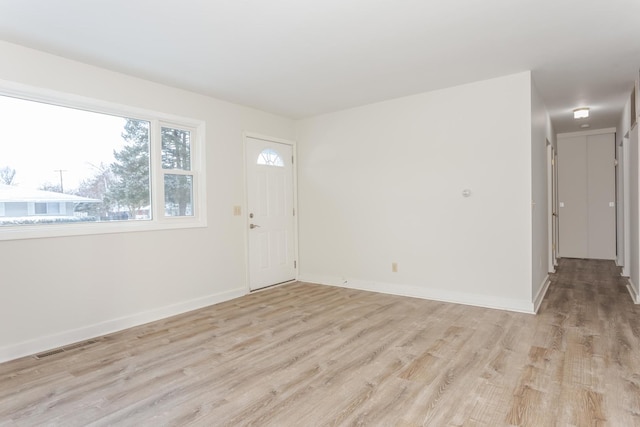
[0,0,640,132]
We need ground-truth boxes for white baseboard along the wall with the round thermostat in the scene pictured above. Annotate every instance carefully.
[298,274,535,314]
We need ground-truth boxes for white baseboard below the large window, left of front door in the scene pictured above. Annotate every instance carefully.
[0,288,247,363]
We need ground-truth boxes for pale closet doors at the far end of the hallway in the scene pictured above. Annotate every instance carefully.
[558,133,616,259]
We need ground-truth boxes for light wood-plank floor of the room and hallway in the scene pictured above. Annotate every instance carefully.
[0,260,640,426]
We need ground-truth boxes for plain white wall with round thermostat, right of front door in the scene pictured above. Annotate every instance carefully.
[297,72,546,311]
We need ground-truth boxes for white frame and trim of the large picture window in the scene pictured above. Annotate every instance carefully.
[0,80,207,241]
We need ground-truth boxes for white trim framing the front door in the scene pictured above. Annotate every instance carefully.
[241,132,300,293]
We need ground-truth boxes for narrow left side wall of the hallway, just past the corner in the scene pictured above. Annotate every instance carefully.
[531,81,555,308]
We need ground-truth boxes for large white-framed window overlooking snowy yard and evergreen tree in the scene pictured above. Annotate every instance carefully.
[0,87,206,239]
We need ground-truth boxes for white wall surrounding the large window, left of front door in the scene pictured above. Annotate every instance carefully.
[0,42,294,361]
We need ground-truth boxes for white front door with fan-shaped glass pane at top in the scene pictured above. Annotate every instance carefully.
[245,137,296,290]
